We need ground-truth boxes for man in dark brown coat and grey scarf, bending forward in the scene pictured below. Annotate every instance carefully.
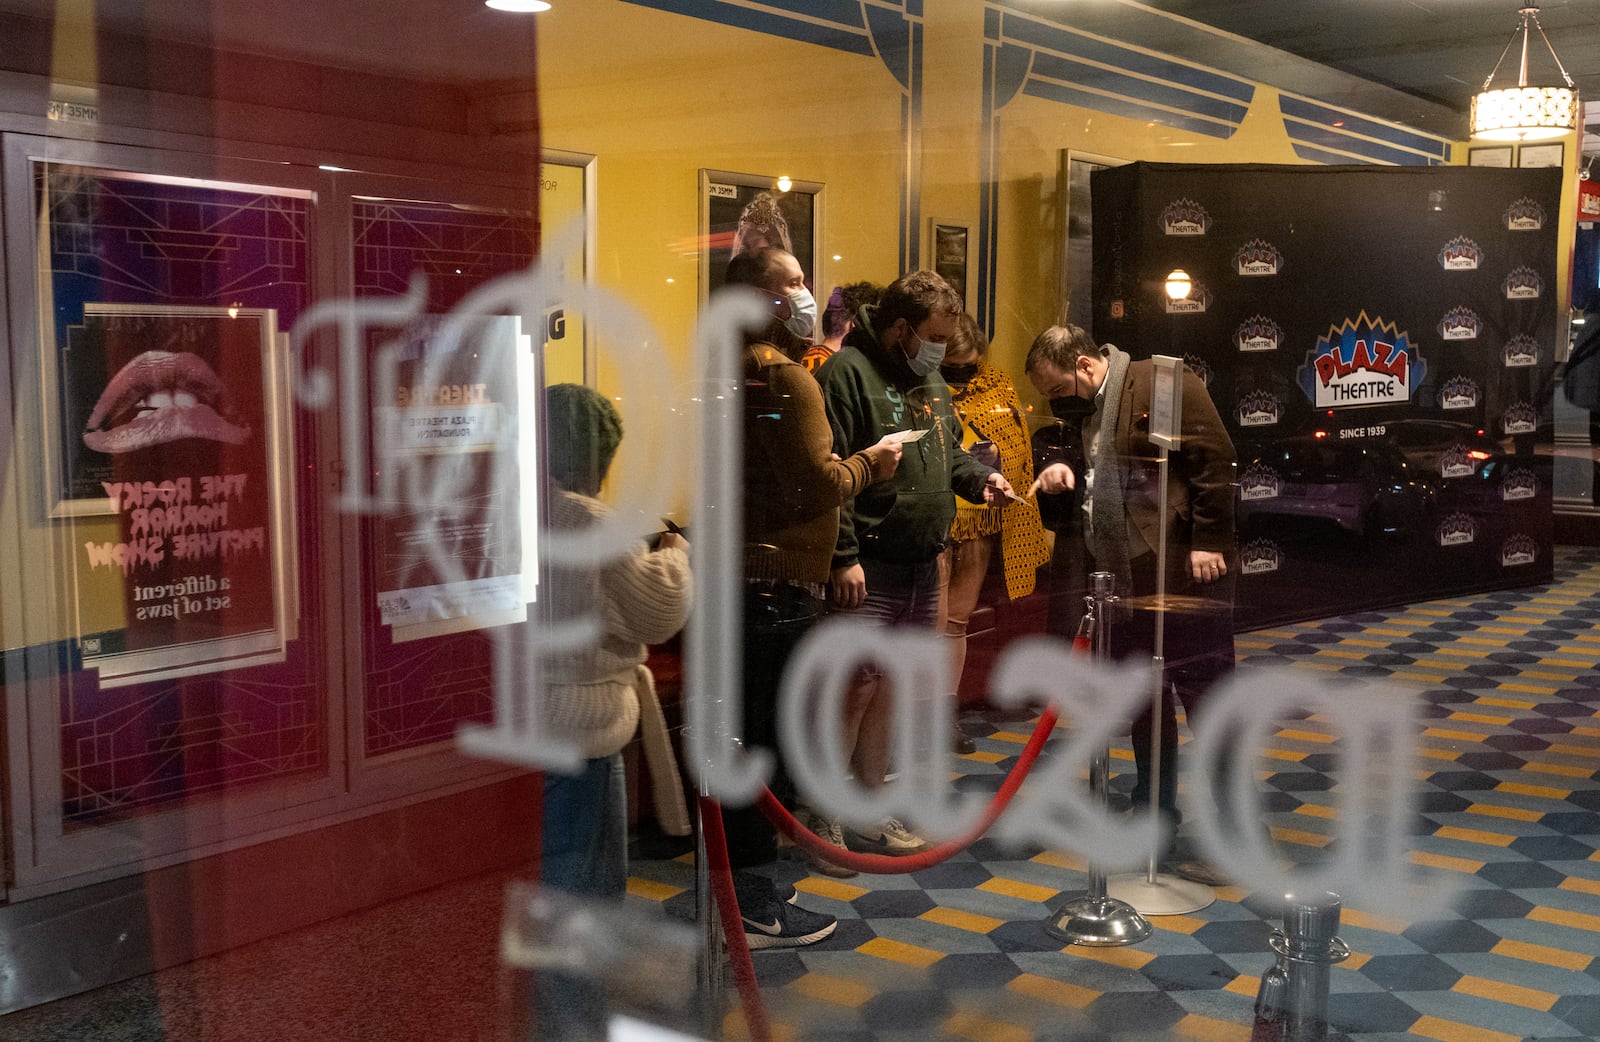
[1024,325,1237,882]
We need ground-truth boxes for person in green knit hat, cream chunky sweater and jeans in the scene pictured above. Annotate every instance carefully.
[539,384,693,898]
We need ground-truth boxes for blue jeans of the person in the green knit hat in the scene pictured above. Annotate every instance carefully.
[539,752,627,898]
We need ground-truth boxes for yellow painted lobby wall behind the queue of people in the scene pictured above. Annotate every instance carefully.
[0,0,1576,647]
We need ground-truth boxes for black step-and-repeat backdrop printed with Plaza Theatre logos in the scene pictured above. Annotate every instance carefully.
[1091,163,1563,629]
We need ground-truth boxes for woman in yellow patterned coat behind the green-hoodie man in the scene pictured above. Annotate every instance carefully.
[939,314,1050,729]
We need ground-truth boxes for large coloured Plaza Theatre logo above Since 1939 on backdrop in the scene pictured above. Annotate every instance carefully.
[1299,311,1427,408]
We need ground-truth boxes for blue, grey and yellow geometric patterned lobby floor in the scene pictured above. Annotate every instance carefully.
[630,547,1600,1042]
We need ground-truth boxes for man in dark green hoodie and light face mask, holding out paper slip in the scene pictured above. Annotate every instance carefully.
[816,271,1011,853]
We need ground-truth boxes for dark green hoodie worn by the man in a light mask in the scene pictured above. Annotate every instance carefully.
[816,306,994,568]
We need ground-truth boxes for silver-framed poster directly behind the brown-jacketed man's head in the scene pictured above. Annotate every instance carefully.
[699,170,822,299]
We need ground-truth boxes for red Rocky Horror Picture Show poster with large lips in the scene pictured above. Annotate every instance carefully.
[56,304,293,687]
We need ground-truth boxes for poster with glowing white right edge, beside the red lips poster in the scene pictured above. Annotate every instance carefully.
[373,315,538,642]
